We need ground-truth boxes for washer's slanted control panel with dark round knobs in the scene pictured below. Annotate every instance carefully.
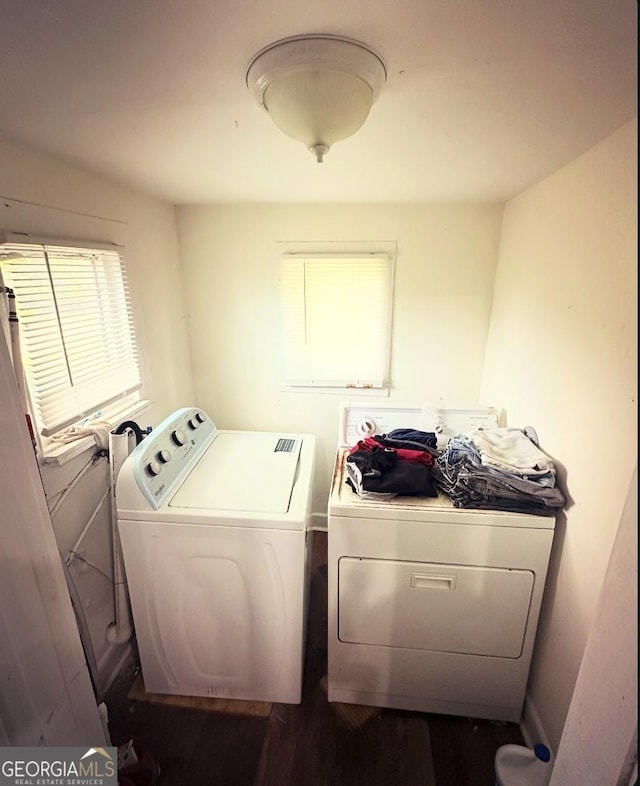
[121,407,216,510]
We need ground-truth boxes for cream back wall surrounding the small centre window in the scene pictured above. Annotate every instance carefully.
[177,199,502,514]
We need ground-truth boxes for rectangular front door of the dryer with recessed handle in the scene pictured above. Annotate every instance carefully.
[338,557,534,658]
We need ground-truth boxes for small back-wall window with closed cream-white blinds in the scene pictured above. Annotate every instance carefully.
[281,253,393,391]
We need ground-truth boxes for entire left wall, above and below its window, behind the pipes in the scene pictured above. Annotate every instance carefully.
[0,136,193,691]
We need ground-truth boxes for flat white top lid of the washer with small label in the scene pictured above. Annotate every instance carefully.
[169,431,302,513]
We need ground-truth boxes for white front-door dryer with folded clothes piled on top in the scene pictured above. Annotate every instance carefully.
[328,402,555,722]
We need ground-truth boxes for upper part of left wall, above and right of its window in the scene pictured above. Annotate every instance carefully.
[0,140,192,416]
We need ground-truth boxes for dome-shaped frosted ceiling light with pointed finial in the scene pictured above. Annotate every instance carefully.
[246,35,387,163]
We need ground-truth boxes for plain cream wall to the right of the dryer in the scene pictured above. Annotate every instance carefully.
[482,116,637,747]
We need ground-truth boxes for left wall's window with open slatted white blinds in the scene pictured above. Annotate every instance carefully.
[0,243,141,436]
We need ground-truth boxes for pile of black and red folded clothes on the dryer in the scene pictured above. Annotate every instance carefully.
[346,429,438,500]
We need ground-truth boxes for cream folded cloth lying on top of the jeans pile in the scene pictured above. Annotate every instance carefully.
[467,428,555,476]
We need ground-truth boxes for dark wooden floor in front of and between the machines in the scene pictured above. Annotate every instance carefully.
[105,532,523,786]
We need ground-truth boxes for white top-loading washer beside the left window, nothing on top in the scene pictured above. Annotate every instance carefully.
[116,408,315,704]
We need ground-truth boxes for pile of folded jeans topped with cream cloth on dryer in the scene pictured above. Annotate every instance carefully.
[433,426,566,516]
